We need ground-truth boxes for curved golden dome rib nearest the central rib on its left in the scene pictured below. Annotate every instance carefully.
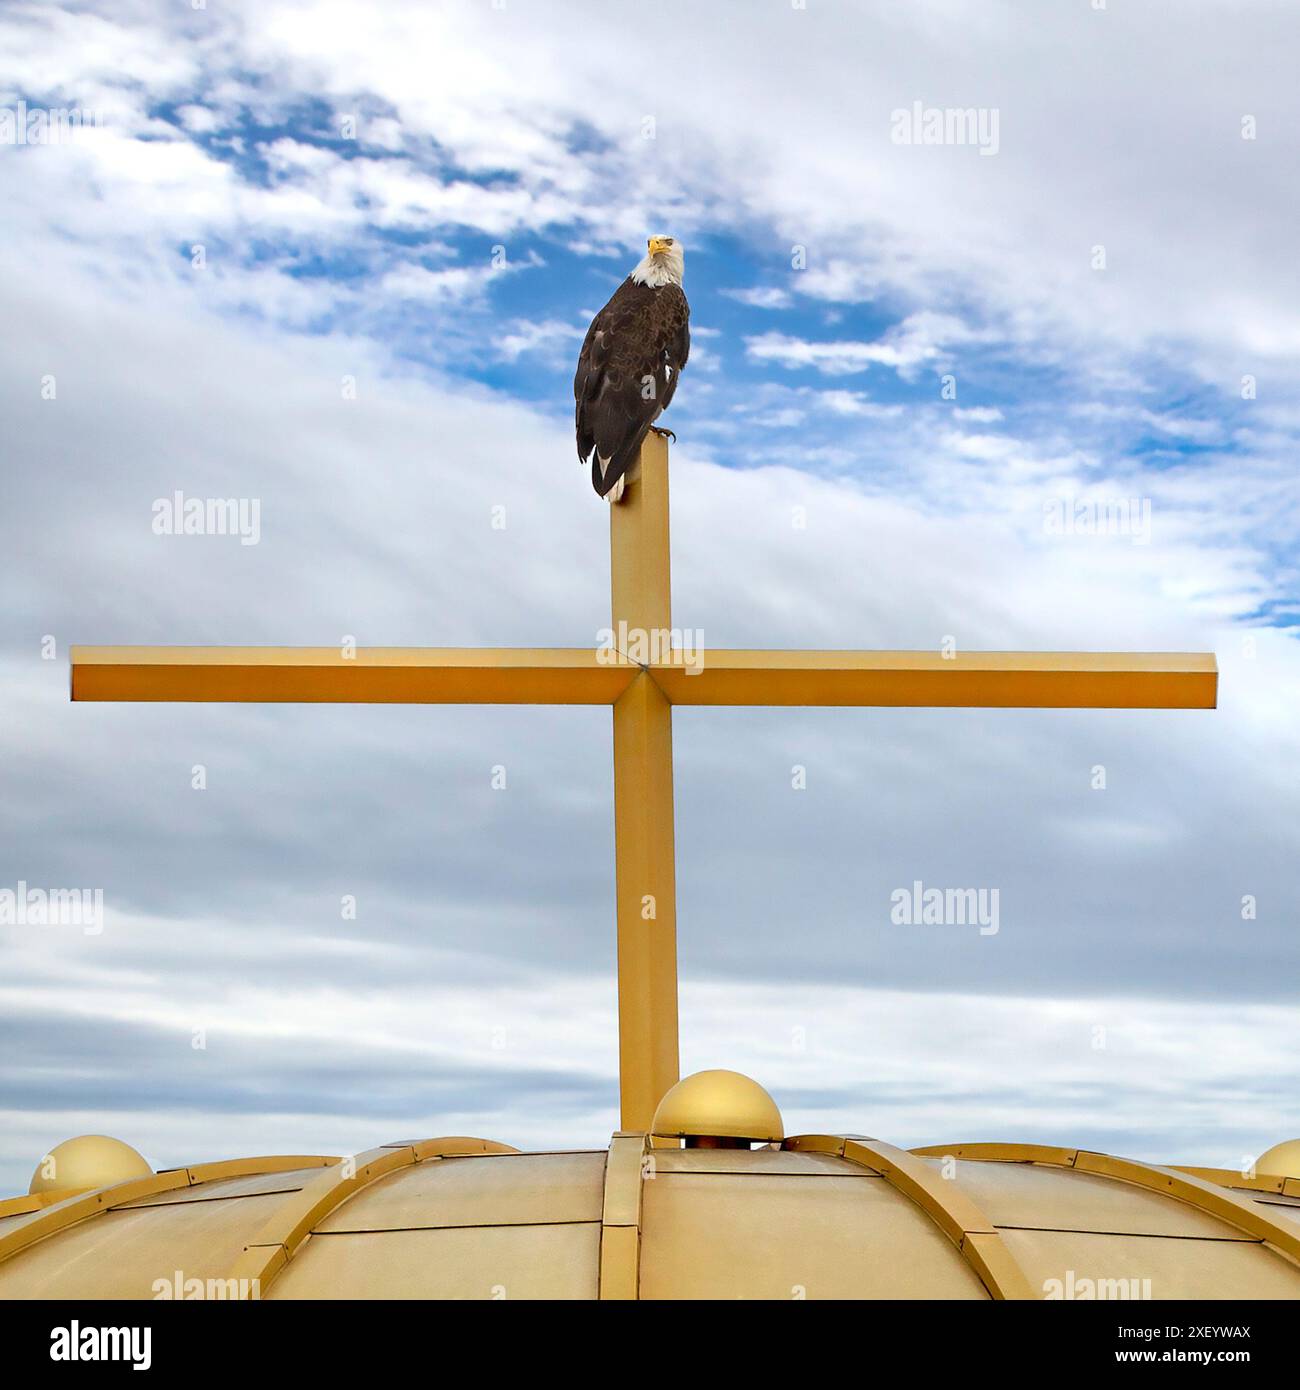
[225,1136,519,1298]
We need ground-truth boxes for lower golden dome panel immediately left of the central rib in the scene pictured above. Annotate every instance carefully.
[266,1228,601,1300]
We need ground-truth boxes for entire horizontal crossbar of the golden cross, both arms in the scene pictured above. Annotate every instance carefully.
[72,646,1218,709]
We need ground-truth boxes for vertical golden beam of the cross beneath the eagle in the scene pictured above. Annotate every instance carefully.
[609,435,679,1130]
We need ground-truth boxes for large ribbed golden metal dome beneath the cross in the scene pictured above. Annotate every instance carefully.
[0,1128,1300,1302]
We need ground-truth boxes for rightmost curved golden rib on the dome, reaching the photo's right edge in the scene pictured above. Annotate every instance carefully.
[912,1144,1300,1265]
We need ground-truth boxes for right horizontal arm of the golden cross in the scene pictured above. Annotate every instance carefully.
[649,649,1218,709]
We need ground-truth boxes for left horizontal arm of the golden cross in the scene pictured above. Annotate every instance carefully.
[71,646,640,705]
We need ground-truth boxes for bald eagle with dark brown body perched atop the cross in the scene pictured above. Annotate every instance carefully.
[573,236,691,502]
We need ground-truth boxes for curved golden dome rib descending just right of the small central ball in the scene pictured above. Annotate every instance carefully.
[781,1134,1039,1301]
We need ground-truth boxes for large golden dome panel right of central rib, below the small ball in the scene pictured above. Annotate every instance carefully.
[641,1173,989,1300]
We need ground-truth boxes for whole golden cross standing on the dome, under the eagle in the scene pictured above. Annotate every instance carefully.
[71,435,1218,1131]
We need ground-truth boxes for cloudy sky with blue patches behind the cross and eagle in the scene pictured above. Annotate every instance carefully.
[0,0,1300,1191]
